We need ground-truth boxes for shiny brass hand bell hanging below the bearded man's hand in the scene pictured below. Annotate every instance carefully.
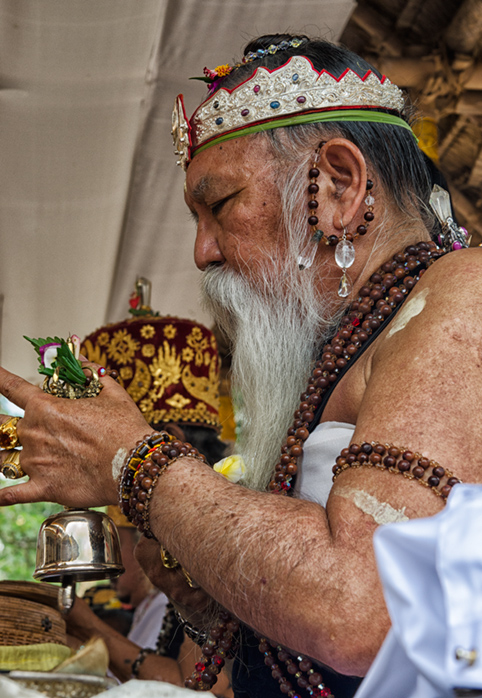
[33,509,124,613]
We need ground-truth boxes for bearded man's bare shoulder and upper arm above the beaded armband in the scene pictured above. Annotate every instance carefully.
[356,248,482,482]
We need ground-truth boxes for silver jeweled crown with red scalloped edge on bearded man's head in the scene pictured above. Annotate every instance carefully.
[173,56,404,166]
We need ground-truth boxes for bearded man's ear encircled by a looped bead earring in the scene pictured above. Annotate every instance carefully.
[319,138,367,230]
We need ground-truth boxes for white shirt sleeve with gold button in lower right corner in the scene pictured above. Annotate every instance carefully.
[356,485,482,698]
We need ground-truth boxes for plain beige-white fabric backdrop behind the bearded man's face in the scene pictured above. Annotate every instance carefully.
[0,0,354,379]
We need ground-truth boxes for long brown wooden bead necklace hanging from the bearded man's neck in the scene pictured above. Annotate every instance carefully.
[186,237,444,698]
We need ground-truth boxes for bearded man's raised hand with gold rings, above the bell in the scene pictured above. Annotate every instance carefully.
[0,368,151,507]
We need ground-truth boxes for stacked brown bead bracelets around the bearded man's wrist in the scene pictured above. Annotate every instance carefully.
[119,431,206,538]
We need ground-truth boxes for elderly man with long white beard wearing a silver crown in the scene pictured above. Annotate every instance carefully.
[0,36,482,698]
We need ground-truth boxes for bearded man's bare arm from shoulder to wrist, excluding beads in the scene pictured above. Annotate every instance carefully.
[151,251,482,674]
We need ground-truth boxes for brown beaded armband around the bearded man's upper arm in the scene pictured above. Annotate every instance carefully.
[333,441,461,500]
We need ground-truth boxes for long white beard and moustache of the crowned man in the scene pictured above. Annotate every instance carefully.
[202,261,333,491]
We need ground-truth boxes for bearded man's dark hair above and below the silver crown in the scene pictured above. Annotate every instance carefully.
[215,34,433,224]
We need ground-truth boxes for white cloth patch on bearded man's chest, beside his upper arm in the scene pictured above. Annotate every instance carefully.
[295,422,355,506]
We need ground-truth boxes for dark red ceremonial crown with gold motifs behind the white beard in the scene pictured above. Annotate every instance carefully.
[81,280,220,429]
